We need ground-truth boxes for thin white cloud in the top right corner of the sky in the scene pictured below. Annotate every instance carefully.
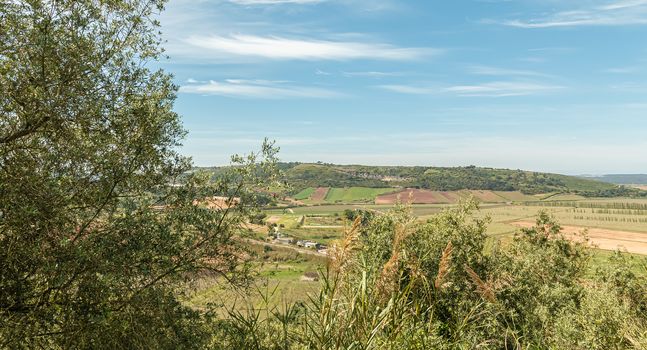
[492,0,647,28]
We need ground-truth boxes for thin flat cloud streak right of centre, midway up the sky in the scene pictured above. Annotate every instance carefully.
[379,81,564,97]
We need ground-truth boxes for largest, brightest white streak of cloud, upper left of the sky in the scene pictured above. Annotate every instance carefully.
[186,34,443,61]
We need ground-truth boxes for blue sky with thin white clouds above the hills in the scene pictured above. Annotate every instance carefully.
[159,0,647,174]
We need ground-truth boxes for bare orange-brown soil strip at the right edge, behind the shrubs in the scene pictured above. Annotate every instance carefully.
[512,221,647,255]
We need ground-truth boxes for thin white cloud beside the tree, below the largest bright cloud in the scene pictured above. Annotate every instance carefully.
[180,79,343,99]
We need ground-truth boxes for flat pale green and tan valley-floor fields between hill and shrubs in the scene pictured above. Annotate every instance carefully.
[268,197,647,254]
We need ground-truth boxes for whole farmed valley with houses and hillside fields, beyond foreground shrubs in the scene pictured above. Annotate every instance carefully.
[194,164,647,344]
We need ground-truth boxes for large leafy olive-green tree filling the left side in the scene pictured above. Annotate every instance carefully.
[0,0,275,349]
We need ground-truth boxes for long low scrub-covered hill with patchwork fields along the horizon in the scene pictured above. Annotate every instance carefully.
[280,163,642,197]
